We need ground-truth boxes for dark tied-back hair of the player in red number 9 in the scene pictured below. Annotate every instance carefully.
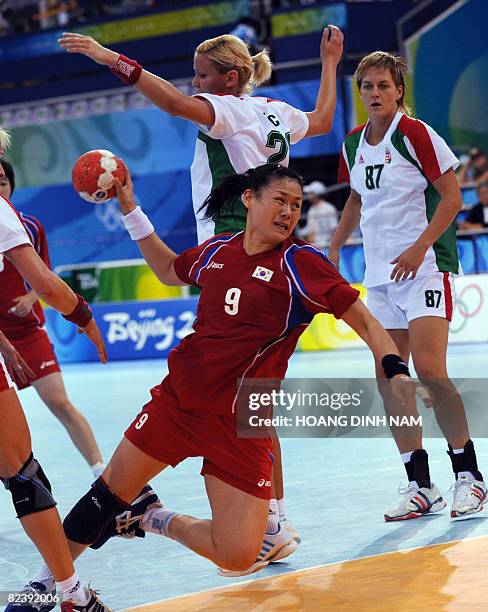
[199,164,303,219]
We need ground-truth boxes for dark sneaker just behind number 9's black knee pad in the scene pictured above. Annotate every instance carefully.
[90,485,163,550]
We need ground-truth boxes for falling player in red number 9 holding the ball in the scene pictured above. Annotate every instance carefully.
[30,164,426,588]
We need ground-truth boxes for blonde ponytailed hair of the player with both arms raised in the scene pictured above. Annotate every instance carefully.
[196,34,273,94]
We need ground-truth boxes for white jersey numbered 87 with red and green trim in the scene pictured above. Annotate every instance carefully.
[339,112,460,287]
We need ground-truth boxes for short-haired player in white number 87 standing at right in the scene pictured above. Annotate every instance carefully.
[329,51,486,521]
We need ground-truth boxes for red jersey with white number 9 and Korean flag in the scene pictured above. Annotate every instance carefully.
[158,232,359,414]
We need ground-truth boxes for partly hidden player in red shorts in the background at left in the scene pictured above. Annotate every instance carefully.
[0,159,105,478]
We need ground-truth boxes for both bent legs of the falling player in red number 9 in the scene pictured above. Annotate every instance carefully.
[36,438,286,573]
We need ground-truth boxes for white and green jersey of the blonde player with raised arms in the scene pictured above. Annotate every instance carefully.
[191,94,308,244]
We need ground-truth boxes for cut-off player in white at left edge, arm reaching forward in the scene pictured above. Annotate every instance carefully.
[0,128,108,612]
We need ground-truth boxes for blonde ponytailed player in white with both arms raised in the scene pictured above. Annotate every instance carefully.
[60,26,343,558]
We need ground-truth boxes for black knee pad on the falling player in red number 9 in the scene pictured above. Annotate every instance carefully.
[63,476,130,544]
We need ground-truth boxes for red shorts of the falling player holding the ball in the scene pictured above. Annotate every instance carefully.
[125,378,273,499]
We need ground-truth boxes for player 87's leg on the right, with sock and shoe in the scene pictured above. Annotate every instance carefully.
[409,317,487,518]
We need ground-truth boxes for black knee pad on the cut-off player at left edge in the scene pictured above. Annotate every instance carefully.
[2,453,56,518]
